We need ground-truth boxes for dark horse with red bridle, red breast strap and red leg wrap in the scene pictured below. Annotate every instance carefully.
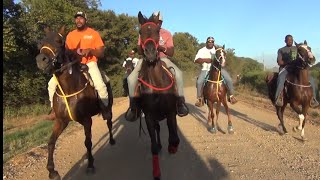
[138,12,180,179]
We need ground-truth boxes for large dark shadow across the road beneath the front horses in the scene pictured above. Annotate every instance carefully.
[63,110,229,180]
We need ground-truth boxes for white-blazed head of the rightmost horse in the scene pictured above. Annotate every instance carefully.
[294,41,316,69]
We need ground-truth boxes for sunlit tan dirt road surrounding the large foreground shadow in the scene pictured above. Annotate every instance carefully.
[3,87,320,180]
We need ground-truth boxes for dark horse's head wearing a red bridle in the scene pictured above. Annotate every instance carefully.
[138,11,160,63]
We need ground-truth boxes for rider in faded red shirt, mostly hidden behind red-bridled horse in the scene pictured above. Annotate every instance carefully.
[127,11,189,121]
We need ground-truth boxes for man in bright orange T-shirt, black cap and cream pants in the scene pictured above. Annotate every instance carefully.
[48,11,108,119]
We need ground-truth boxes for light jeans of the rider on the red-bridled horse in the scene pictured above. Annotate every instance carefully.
[128,57,184,97]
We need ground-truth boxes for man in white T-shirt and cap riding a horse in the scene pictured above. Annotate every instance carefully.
[194,37,216,107]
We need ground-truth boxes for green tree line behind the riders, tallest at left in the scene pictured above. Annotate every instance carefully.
[3,0,318,110]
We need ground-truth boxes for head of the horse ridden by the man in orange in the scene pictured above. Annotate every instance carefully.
[36,26,65,73]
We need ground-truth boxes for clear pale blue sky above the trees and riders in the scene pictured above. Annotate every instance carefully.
[99,0,320,67]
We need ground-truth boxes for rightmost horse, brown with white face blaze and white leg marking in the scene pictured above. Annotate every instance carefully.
[266,41,316,139]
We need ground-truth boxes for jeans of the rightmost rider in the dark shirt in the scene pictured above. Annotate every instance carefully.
[275,68,317,101]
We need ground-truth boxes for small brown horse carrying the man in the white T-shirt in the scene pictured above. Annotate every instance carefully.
[203,45,234,134]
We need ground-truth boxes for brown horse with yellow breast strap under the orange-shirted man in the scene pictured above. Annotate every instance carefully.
[36,26,115,179]
